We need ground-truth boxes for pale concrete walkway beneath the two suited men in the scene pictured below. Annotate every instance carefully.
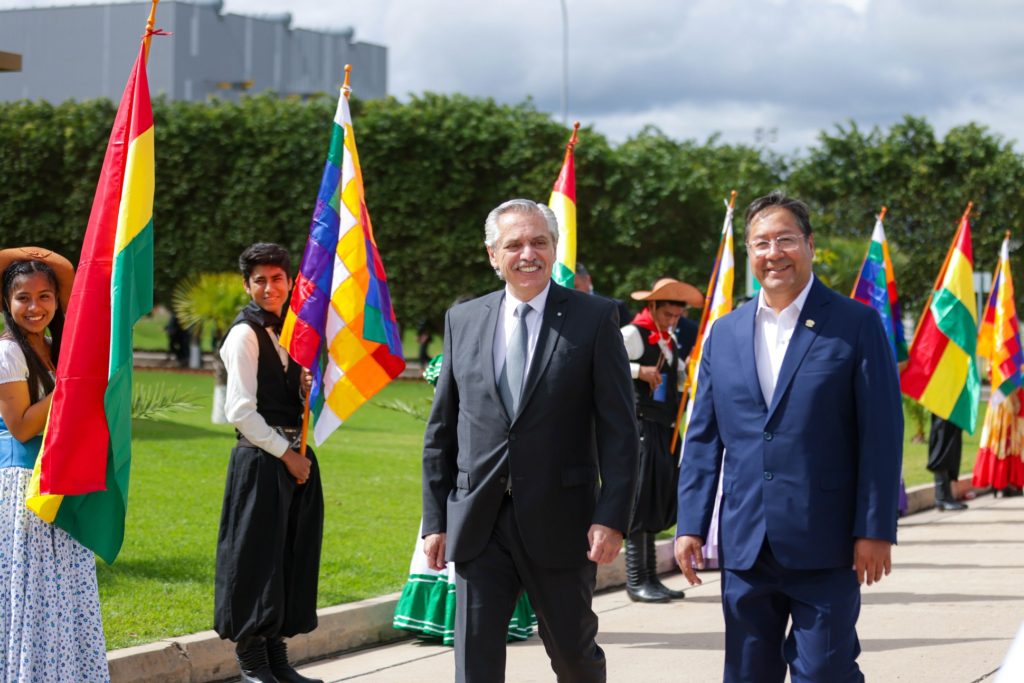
[292,496,1024,683]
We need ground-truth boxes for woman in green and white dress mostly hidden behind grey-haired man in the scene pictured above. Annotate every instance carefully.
[391,355,537,645]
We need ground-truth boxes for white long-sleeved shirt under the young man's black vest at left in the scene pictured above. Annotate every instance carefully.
[220,324,290,458]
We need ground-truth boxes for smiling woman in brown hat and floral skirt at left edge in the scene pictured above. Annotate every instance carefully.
[0,247,110,683]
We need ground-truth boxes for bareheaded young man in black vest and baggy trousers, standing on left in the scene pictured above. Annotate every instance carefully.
[214,243,324,683]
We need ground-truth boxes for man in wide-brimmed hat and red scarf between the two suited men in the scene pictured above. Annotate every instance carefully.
[622,278,703,602]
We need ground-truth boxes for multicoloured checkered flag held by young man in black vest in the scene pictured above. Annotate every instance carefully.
[281,77,406,445]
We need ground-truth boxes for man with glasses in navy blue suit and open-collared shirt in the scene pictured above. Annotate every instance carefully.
[676,191,903,683]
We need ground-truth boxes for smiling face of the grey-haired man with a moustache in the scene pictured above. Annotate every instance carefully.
[487,211,555,301]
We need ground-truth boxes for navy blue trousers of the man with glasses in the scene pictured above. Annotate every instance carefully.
[722,539,864,683]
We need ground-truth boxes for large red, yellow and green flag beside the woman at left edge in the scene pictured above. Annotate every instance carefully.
[27,34,154,563]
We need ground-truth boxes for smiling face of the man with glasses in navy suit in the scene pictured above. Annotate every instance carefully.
[746,207,814,311]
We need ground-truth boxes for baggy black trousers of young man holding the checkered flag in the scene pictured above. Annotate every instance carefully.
[213,446,324,641]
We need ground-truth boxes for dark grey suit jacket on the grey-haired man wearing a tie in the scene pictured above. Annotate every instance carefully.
[423,283,638,567]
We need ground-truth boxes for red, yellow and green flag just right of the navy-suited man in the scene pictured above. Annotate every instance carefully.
[900,207,981,434]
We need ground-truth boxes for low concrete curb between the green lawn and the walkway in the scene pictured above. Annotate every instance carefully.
[106,474,983,683]
